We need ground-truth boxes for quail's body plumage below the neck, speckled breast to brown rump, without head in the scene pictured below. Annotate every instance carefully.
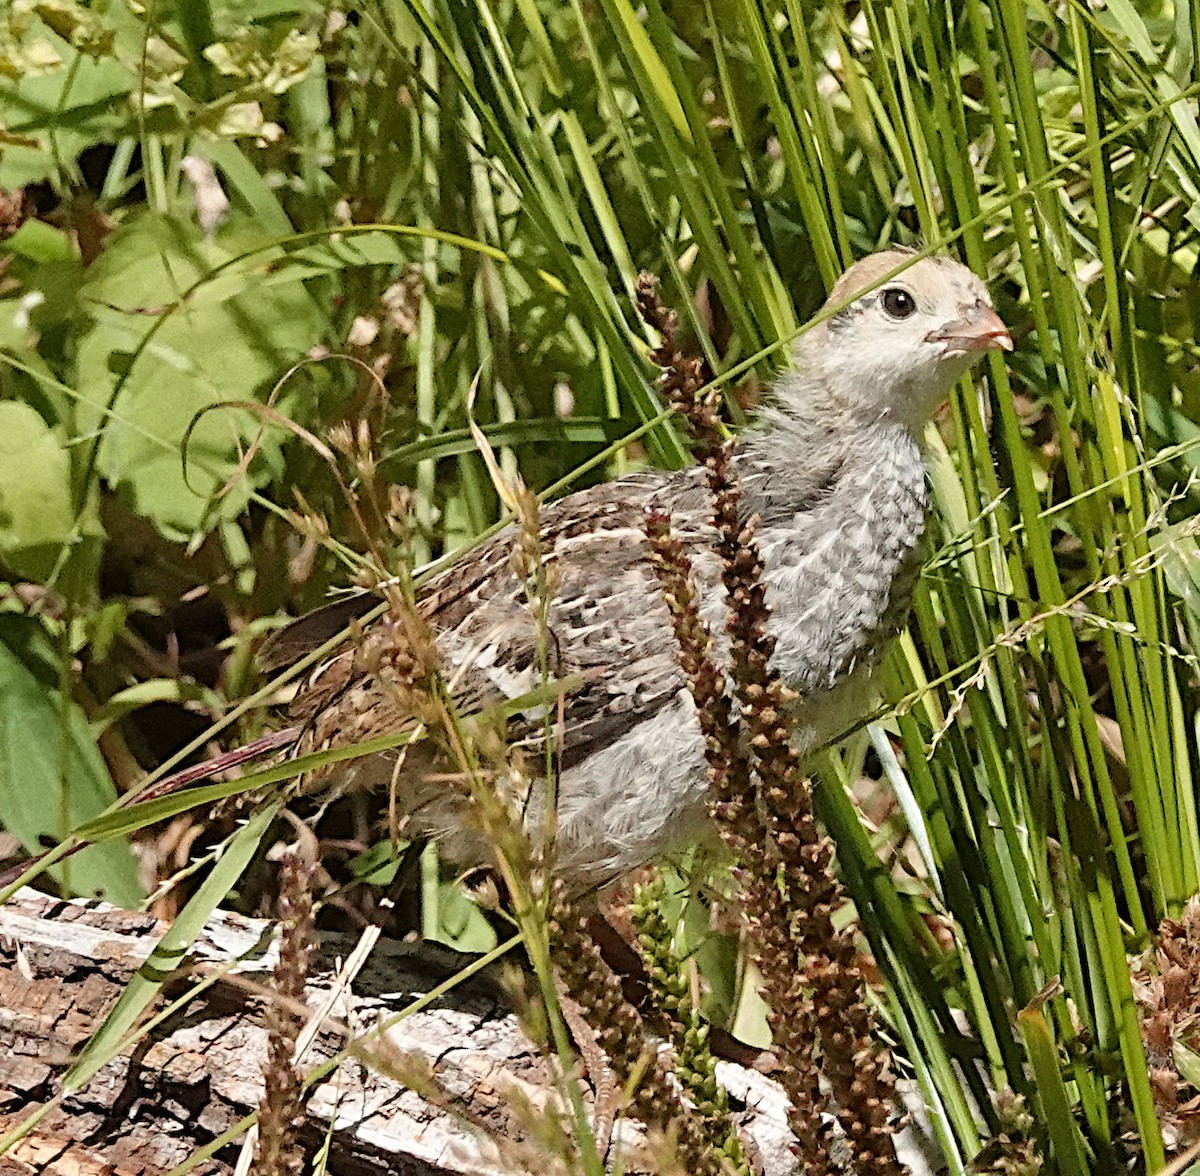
[285,424,925,886]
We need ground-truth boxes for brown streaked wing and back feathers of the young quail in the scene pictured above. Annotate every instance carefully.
[274,470,704,767]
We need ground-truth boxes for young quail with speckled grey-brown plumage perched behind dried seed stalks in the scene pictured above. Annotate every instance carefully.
[270,250,1012,890]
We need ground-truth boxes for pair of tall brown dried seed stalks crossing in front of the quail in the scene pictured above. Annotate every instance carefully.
[637,275,904,1174]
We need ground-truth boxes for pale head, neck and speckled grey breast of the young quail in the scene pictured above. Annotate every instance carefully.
[738,250,1012,696]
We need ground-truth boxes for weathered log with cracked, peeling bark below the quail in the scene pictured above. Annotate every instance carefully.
[0,890,816,1176]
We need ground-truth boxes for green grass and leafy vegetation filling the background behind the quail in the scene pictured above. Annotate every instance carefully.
[0,0,1200,1172]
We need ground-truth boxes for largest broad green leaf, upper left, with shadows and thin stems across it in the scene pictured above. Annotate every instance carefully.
[77,217,323,539]
